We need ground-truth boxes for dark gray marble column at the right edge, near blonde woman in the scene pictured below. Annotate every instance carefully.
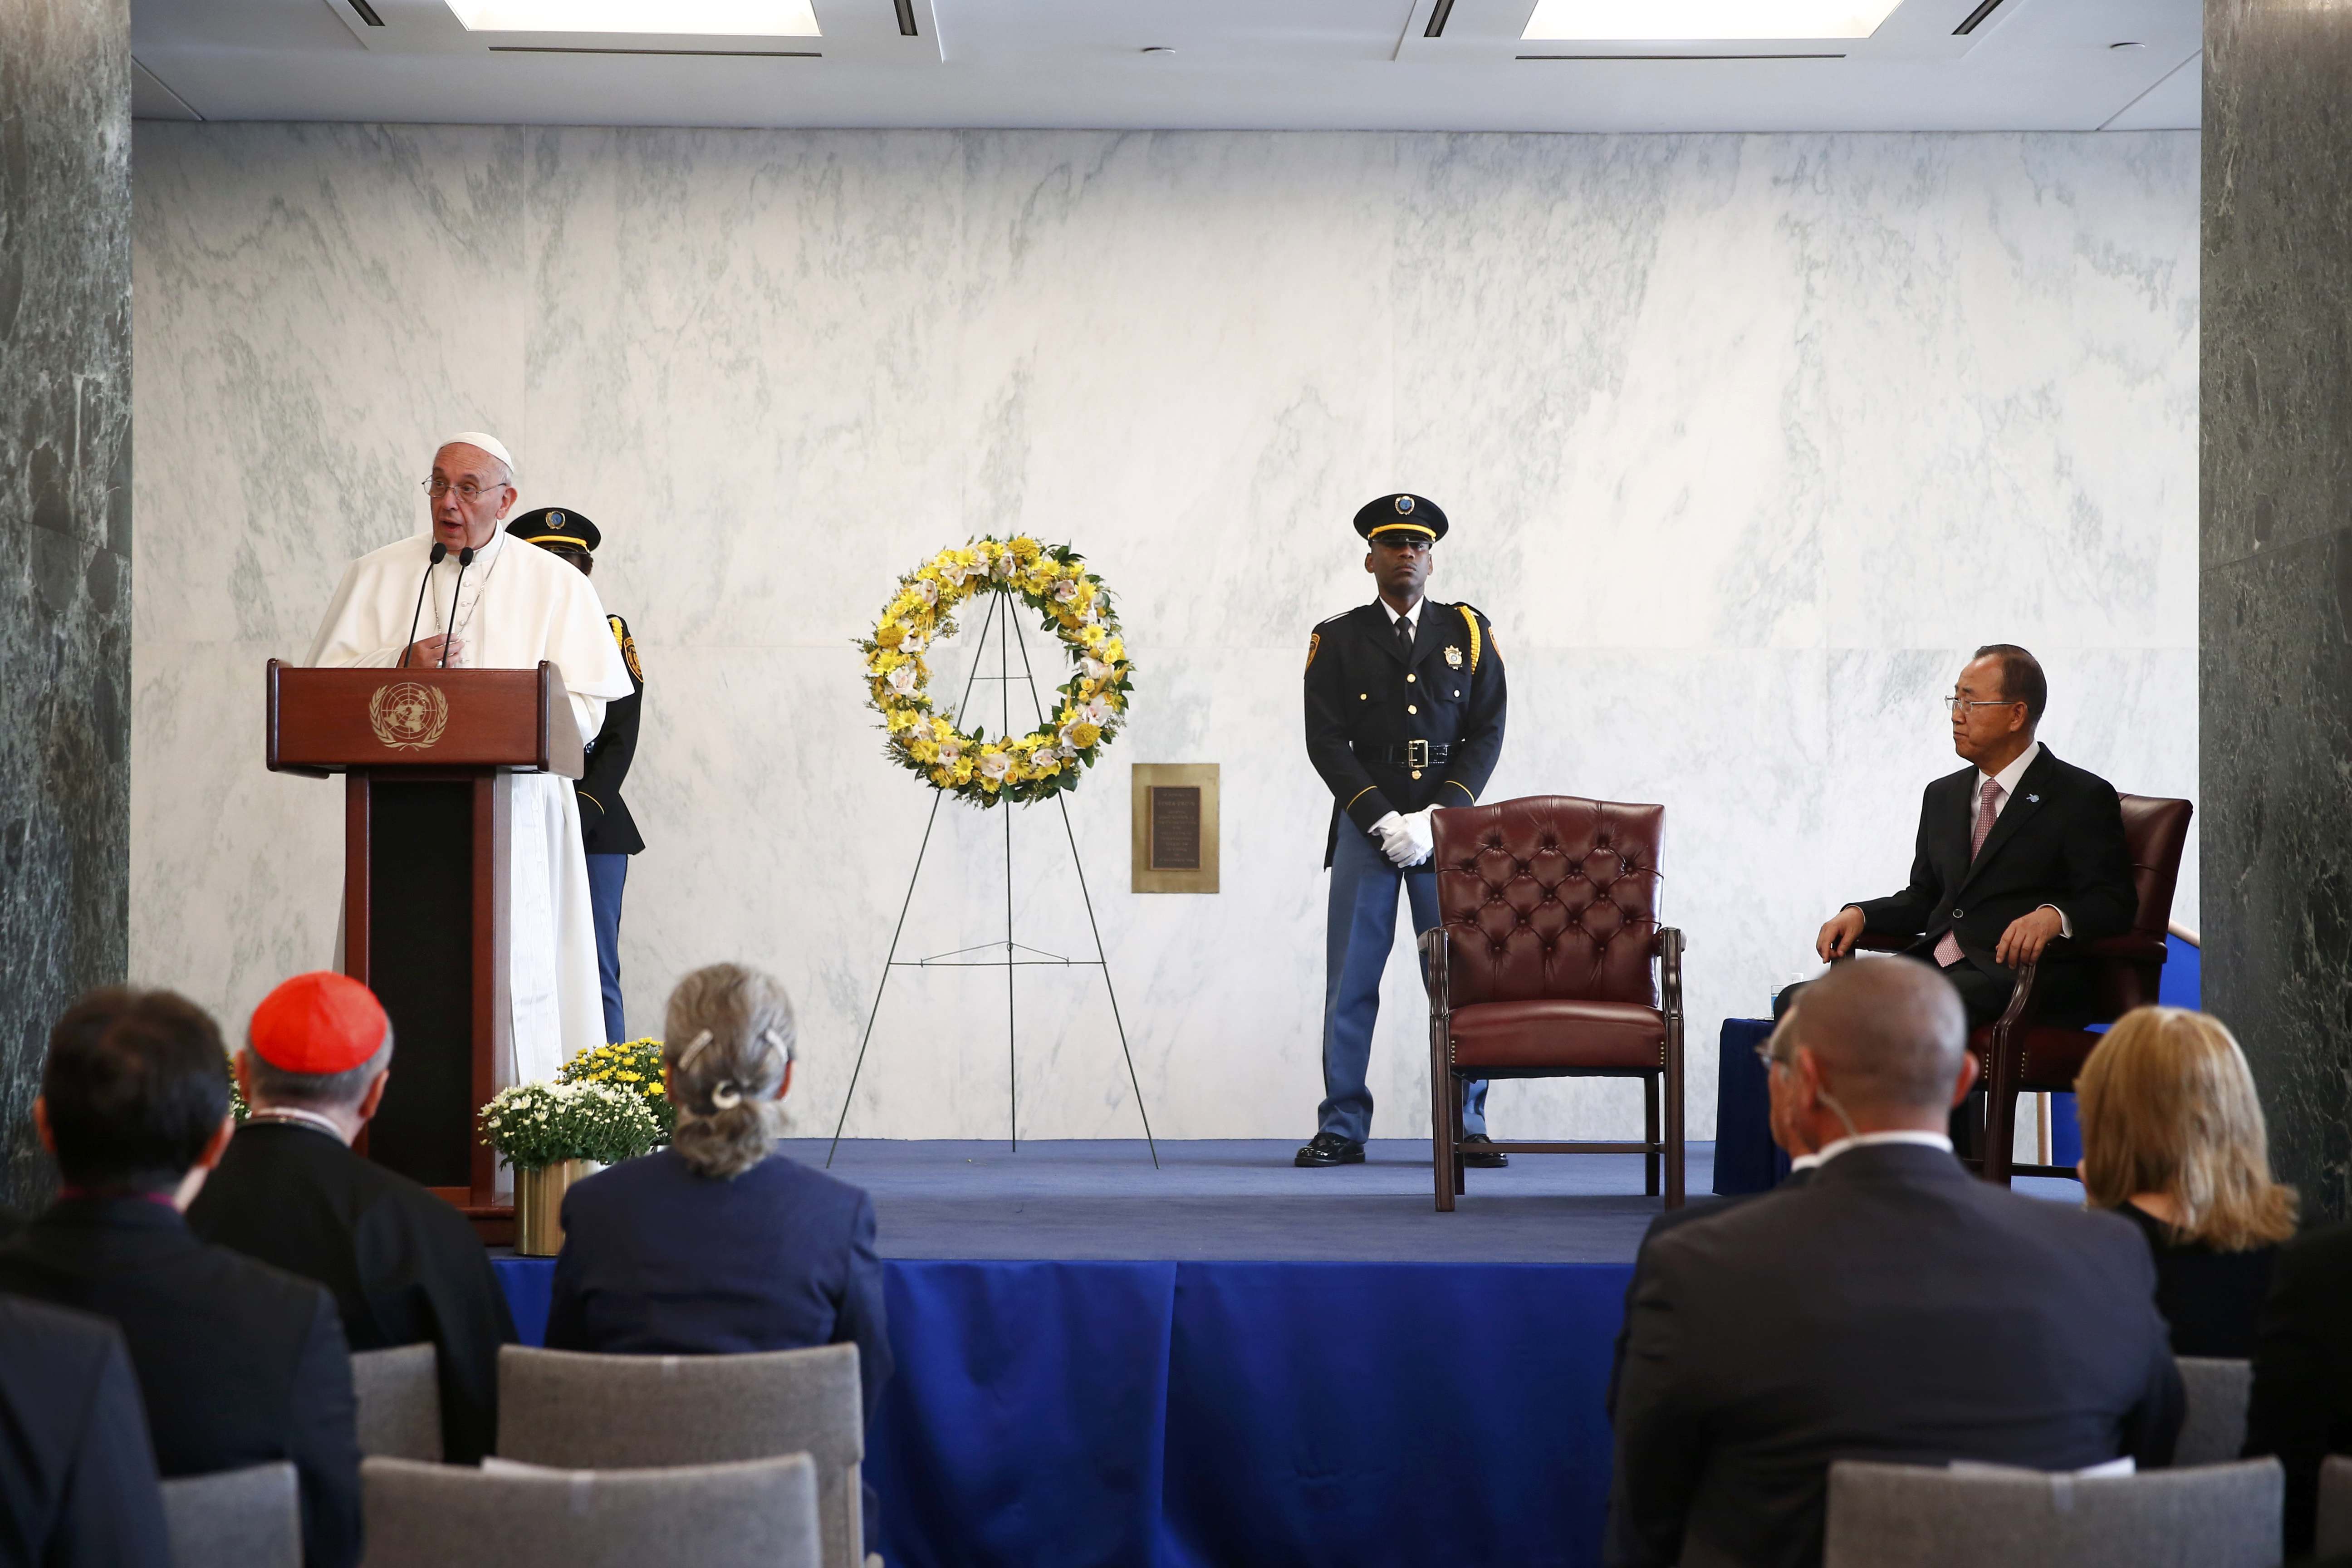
[2199,0,2352,1218]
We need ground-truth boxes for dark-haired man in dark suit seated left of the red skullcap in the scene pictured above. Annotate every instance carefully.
[0,987,360,1568]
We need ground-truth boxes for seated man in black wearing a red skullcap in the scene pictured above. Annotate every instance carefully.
[188,973,515,1465]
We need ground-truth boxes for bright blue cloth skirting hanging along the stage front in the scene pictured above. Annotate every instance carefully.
[499,1258,1630,1568]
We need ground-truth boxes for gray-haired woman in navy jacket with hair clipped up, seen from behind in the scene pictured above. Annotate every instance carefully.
[548,964,892,1540]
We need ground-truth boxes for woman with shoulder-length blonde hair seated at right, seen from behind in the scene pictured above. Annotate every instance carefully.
[2074,1006,2296,1357]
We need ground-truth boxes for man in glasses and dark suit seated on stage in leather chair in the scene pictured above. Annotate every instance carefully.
[1783,642,2138,1044]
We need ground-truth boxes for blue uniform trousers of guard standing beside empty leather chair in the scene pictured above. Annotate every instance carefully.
[1317,820,1486,1142]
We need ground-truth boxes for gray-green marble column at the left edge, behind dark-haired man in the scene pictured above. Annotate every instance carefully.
[0,0,132,1206]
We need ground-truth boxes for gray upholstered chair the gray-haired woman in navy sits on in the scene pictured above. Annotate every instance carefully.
[499,1345,866,1568]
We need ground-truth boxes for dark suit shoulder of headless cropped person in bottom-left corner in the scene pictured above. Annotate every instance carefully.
[0,1295,172,1568]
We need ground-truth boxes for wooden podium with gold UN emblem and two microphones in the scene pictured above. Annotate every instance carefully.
[268,658,581,1241]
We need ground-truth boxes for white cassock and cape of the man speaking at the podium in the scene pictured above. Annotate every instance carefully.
[306,529,630,1084]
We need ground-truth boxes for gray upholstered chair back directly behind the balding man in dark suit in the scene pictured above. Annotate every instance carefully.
[1820,1460,2286,1568]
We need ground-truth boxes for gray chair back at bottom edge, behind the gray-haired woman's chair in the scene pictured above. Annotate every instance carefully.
[360,1453,823,1568]
